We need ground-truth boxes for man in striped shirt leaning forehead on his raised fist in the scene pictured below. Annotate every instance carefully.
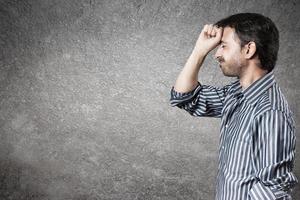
[170,13,298,200]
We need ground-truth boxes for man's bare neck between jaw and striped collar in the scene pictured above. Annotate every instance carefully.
[239,67,268,91]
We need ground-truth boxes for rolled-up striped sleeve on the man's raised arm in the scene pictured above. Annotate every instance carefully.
[170,82,230,118]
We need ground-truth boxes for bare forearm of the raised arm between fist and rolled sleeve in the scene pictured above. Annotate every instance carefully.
[174,49,207,92]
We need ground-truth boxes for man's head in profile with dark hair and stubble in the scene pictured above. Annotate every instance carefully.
[214,13,279,76]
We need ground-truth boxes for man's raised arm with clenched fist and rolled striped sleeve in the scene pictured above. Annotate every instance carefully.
[170,24,230,117]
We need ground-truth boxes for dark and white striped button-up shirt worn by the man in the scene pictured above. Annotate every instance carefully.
[170,71,298,200]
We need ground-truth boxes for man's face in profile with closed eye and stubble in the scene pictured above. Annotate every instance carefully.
[215,27,245,77]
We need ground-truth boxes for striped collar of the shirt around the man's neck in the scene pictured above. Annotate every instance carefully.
[232,70,275,105]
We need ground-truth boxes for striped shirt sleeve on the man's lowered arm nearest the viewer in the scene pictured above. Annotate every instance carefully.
[249,110,298,200]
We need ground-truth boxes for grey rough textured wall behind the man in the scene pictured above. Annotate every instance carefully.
[0,0,300,200]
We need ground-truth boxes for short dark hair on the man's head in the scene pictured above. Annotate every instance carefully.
[214,13,279,72]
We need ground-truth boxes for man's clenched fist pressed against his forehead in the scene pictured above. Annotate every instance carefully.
[194,24,223,55]
